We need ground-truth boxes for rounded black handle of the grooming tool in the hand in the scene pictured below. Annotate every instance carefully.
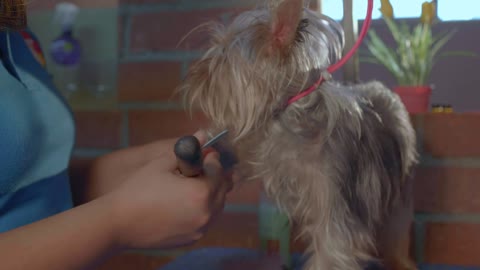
[174,136,203,177]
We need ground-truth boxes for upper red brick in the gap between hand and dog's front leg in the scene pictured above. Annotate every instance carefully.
[227,181,262,204]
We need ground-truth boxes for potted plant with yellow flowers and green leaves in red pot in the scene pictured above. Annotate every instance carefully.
[364,0,468,113]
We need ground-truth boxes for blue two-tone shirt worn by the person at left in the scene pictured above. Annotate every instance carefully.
[0,31,75,232]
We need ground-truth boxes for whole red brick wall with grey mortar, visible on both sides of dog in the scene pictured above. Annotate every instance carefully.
[63,0,480,269]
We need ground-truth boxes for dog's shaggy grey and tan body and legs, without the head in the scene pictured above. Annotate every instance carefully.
[254,79,417,269]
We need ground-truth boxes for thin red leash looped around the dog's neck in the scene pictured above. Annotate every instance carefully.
[287,0,373,106]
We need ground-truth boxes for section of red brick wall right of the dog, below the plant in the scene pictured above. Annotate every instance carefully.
[414,113,480,268]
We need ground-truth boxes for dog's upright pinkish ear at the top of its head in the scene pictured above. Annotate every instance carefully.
[271,0,304,49]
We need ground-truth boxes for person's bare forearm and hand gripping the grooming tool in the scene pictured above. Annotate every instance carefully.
[0,133,230,270]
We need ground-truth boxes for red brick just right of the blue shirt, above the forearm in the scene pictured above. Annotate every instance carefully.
[75,111,122,148]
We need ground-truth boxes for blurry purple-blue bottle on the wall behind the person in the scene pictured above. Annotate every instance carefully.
[50,3,82,66]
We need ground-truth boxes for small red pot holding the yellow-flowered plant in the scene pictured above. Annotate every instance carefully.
[393,86,432,114]
